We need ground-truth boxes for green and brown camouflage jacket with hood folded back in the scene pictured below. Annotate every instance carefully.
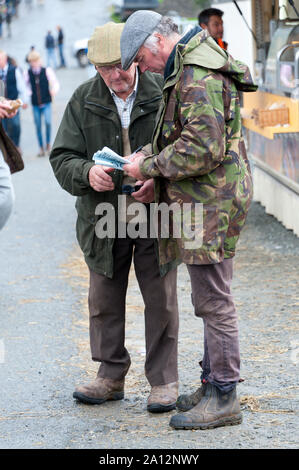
[140,27,257,264]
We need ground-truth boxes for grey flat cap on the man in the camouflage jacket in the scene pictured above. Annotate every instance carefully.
[120,10,162,70]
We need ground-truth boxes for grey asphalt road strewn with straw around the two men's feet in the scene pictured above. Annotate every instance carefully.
[0,0,299,450]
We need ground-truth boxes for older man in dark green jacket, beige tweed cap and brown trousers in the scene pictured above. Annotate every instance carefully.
[50,22,178,412]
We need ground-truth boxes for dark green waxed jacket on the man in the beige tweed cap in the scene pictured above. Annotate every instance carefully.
[50,72,166,278]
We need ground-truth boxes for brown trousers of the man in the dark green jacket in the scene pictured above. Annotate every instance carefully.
[89,237,179,386]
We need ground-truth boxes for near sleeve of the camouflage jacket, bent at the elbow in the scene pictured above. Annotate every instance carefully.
[140,67,225,180]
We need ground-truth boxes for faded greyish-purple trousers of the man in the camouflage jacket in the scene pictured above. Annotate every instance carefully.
[187,259,240,392]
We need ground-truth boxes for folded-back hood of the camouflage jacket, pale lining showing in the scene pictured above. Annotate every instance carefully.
[172,30,257,91]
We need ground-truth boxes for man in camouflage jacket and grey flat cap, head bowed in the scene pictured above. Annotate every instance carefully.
[121,11,256,429]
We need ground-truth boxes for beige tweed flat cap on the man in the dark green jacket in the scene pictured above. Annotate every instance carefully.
[87,21,124,67]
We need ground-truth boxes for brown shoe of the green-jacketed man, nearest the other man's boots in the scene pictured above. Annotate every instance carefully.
[147,382,179,413]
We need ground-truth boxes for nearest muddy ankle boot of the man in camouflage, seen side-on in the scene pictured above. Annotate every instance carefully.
[169,383,242,429]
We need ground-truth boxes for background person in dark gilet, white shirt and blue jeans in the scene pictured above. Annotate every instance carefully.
[25,51,59,157]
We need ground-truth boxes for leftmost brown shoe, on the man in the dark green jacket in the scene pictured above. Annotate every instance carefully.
[73,377,125,405]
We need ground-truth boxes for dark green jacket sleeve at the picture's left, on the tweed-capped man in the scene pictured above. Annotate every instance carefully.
[50,97,94,196]
